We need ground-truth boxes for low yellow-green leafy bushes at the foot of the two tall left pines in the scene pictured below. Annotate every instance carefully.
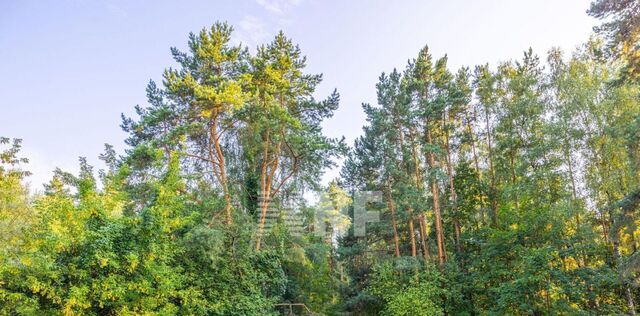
[0,156,284,315]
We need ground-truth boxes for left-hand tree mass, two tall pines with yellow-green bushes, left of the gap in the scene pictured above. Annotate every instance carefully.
[0,23,346,315]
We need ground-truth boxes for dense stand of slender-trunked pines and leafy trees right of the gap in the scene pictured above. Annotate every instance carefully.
[338,1,640,315]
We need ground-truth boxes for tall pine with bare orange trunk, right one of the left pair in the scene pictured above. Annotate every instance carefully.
[248,32,340,250]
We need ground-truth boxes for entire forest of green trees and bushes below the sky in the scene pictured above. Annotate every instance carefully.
[0,0,640,315]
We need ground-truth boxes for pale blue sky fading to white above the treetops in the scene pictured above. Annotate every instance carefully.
[0,0,597,190]
